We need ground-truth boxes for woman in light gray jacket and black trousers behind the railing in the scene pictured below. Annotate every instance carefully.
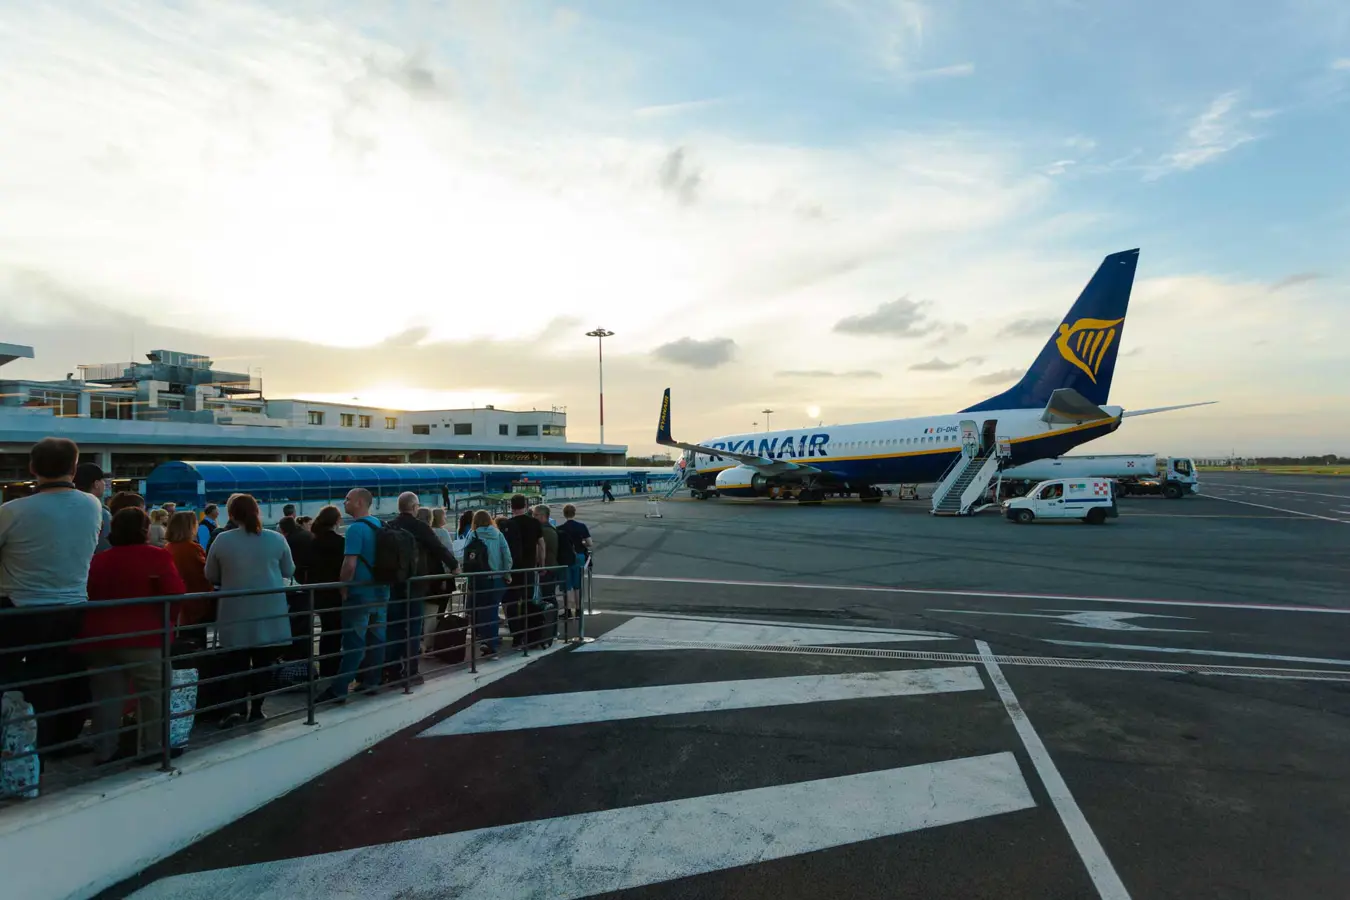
[207,494,296,729]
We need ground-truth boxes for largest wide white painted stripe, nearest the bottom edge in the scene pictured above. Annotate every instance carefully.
[124,753,1035,900]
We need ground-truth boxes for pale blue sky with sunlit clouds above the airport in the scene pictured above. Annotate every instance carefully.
[0,0,1350,455]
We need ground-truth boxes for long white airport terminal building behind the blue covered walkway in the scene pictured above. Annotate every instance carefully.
[0,344,628,496]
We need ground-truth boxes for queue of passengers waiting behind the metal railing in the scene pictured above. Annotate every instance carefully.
[0,437,591,788]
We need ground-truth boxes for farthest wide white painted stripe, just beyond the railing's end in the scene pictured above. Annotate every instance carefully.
[574,615,956,653]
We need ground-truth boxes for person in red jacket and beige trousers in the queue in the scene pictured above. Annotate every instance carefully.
[80,506,184,764]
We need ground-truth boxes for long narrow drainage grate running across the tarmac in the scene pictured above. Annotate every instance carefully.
[601,636,1350,683]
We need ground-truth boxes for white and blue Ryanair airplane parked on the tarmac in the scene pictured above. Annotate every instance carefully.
[656,250,1215,502]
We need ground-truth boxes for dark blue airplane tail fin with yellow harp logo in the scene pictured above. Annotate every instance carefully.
[961,250,1139,413]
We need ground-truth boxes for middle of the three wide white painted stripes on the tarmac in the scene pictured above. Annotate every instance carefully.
[420,665,984,738]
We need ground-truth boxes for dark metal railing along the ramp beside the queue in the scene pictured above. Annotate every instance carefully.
[0,557,591,803]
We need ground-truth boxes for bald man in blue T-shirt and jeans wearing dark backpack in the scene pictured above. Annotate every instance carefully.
[317,487,394,703]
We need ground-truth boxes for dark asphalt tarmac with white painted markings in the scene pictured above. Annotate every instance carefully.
[108,472,1350,900]
